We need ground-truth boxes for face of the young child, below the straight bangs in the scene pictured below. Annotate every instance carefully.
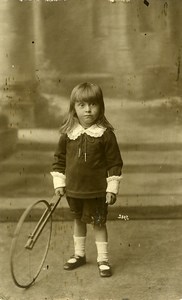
[75,101,100,128]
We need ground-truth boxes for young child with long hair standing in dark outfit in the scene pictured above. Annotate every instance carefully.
[51,82,123,277]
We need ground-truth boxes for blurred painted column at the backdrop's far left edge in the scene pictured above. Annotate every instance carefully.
[0,0,37,127]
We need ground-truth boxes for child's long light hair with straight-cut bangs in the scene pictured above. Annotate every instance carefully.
[60,82,114,133]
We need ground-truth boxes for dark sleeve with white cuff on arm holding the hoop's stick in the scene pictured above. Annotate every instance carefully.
[51,134,66,188]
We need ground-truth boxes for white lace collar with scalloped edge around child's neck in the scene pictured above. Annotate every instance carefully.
[68,124,106,140]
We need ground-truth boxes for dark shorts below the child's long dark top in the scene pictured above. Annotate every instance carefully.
[67,197,108,225]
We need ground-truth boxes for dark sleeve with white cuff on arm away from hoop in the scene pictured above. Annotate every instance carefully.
[105,130,123,194]
